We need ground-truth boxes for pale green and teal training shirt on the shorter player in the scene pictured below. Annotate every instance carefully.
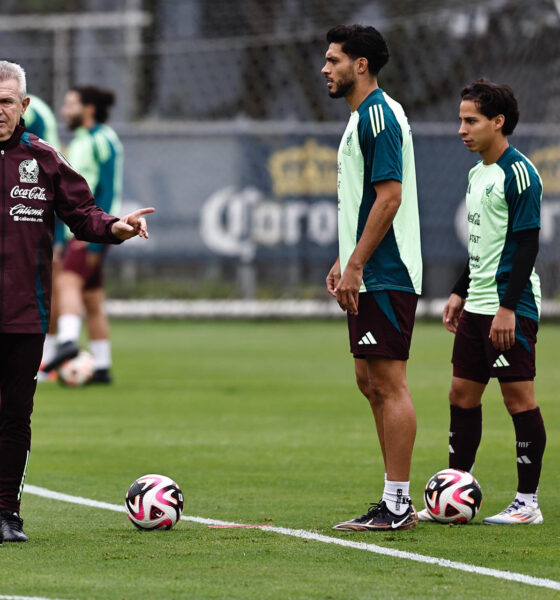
[465,146,542,321]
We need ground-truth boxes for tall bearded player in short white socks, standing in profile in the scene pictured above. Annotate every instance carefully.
[321,25,422,531]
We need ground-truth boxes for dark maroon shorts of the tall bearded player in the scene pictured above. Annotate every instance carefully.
[348,290,418,360]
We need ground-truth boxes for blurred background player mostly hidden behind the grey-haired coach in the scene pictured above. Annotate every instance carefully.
[25,94,65,380]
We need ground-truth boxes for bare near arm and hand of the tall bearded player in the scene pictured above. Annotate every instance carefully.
[336,180,402,315]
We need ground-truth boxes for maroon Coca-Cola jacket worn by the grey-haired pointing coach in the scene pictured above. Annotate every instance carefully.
[0,120,120,333]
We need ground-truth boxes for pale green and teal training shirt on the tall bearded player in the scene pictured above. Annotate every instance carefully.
[338,88,422,294]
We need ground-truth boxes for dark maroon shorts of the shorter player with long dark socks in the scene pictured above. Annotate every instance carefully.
[451,310,539,383]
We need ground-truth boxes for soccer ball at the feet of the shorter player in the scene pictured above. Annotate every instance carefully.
[424,469,482,523]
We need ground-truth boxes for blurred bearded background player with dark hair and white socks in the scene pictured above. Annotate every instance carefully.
[44,86,123,383]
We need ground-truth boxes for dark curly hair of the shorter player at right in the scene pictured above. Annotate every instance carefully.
[461,78,519,135]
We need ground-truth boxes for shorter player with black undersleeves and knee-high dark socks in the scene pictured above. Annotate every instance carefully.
[419,79,546,525]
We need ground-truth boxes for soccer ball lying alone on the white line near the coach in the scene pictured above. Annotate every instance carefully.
[125,475,183,529]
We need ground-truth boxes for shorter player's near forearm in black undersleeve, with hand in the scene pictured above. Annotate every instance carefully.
[490,229,539,351]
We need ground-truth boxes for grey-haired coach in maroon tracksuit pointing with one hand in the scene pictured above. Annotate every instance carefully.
[0,61,154,543]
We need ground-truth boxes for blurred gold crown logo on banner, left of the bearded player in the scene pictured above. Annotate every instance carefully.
[268,139,337,196]
